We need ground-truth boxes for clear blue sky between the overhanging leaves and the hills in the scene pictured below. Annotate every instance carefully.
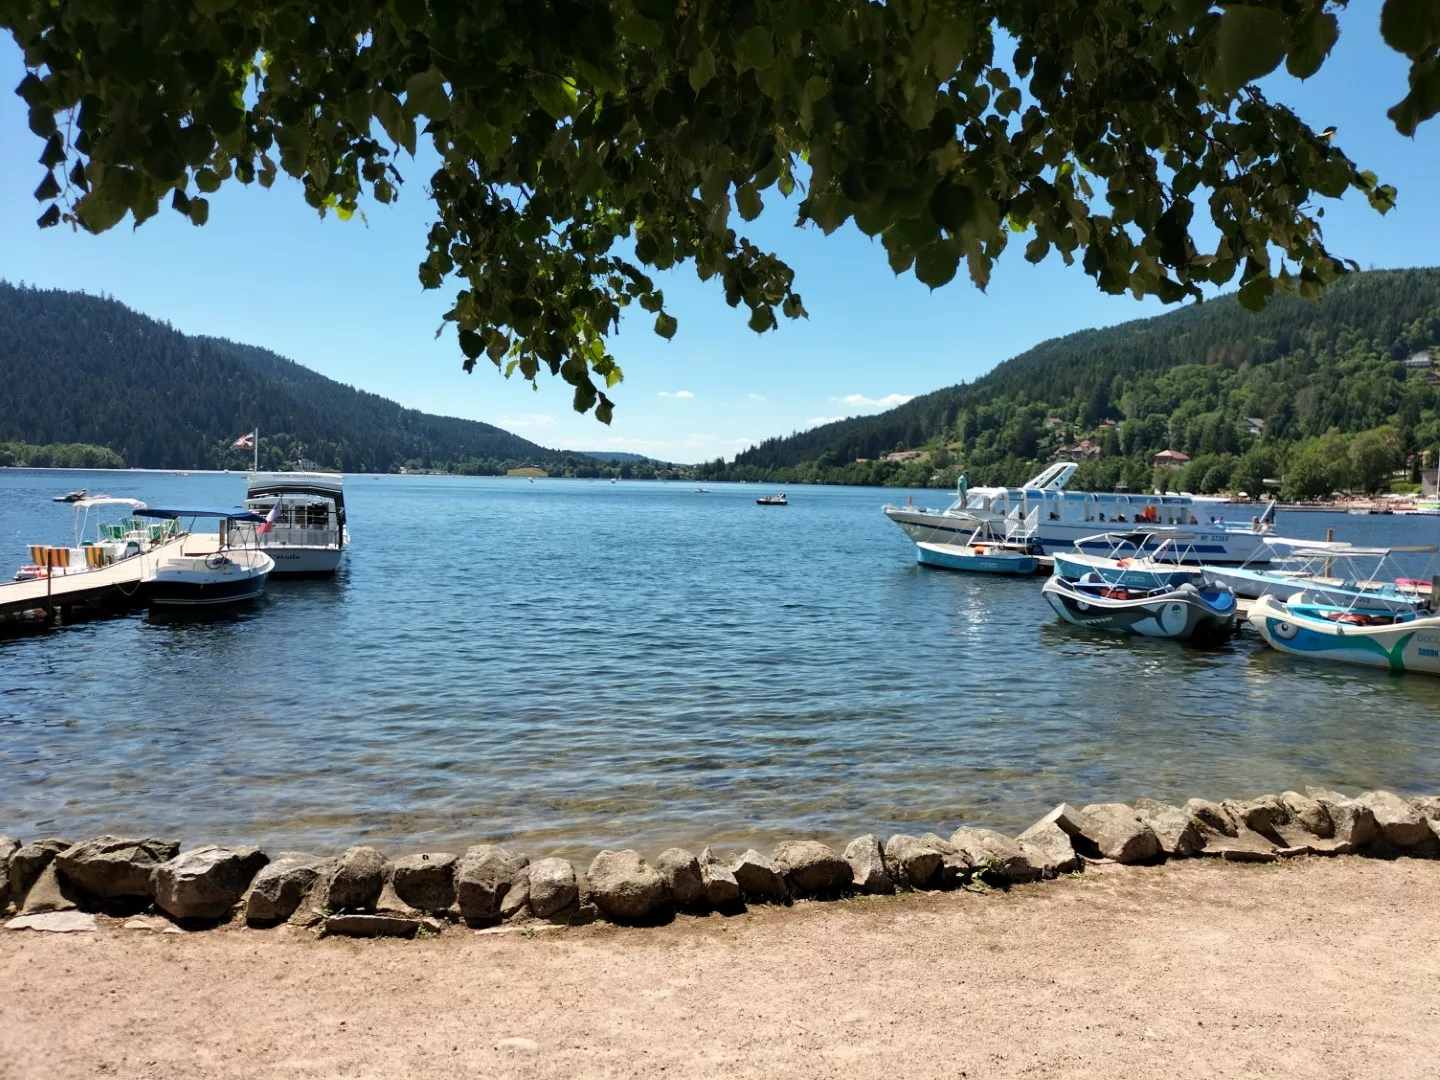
[0,4,1440,461]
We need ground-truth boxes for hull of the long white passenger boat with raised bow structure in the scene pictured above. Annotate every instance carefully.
[884,507,1272,566]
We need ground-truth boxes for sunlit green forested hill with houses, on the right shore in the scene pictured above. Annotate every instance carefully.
[703,268,1440,495]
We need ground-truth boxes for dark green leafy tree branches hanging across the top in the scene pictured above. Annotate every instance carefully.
[0,0,1440,422]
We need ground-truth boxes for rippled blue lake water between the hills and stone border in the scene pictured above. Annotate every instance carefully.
[0,469,1440,858]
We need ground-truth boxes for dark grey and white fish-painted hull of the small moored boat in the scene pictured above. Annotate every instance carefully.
[1041,577,1236,641]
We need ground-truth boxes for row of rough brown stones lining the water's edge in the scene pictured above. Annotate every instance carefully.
[0,788,1440,937]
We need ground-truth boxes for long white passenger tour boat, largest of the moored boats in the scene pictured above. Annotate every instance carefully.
[883,461,1274,566]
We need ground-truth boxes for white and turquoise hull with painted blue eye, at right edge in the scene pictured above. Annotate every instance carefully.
[1250,596,1440,675]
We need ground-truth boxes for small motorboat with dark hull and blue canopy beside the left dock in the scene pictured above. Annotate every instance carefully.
[135,507,275,608]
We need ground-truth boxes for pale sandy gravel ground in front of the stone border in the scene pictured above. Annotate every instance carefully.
[0,858,1440,1080]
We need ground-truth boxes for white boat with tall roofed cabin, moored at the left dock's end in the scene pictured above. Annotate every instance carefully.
[240,472,350,577]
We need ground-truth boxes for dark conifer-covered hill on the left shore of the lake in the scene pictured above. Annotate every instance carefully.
[0,282,596,472]
